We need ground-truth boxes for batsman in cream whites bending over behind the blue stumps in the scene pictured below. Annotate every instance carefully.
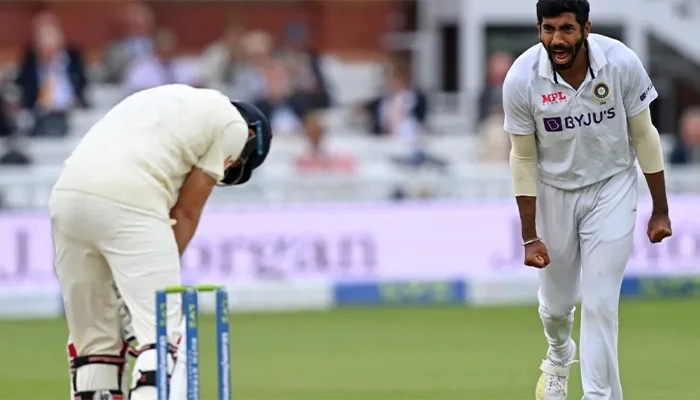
[49,85,272,400]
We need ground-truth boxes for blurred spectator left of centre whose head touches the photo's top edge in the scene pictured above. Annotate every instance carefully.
[102,3,155,83]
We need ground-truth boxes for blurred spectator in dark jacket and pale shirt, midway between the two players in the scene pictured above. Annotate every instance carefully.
[364,59,428,140]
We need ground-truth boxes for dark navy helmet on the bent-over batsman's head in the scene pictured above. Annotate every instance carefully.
[219,101,272,186]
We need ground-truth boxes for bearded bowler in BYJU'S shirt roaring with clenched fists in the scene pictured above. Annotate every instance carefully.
[503,0,671,400]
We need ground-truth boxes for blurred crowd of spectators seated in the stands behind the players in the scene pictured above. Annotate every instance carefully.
[0,3,700,178]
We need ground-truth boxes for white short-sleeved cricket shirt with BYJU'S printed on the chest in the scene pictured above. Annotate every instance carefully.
[503,34,658,190]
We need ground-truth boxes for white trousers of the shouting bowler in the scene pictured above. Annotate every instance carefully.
[537,166,637,400]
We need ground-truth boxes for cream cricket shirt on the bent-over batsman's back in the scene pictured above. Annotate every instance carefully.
[54,85,248,219]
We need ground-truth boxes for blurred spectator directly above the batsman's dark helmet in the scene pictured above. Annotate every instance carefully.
[233,31,301,135]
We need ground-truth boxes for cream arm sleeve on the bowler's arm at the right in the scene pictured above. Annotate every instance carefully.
[627,107,664,174]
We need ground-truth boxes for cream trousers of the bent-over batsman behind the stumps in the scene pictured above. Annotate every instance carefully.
[49,190,182,396]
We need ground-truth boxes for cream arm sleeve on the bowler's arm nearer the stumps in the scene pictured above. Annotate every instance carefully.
[510,134,537,197]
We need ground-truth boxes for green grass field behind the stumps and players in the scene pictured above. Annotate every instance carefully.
[0,300,700,400]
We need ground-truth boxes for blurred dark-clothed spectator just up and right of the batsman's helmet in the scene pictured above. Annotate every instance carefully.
[283,22,331,141]
